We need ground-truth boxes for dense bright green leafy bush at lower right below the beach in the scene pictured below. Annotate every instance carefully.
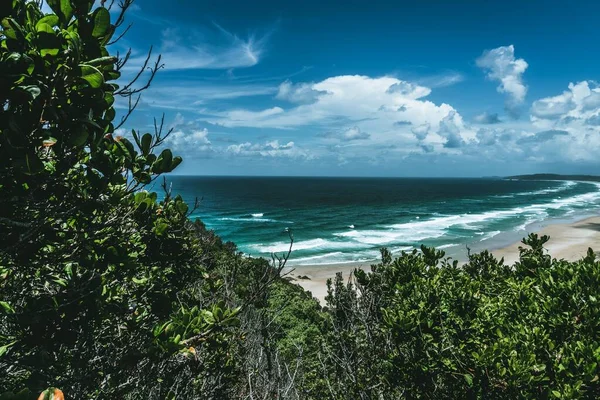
[328,235,600,399]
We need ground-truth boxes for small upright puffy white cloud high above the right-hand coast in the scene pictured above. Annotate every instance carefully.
[476,45,528,116]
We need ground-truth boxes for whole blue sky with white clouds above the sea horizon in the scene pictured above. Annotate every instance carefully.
[90,0,600,177]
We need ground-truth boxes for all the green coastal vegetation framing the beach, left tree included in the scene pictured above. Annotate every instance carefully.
[0,0,600,400]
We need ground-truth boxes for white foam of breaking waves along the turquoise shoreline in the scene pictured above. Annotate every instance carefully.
[243,183,600,265]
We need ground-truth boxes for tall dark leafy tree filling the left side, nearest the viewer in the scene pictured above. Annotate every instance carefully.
[0,0,246,399]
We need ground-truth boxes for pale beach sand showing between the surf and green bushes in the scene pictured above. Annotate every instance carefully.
[283,217,600,304]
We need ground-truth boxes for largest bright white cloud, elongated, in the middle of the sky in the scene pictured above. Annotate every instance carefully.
[209,75,475,145]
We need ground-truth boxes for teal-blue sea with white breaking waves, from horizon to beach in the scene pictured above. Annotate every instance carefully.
[162,176,600,265]
